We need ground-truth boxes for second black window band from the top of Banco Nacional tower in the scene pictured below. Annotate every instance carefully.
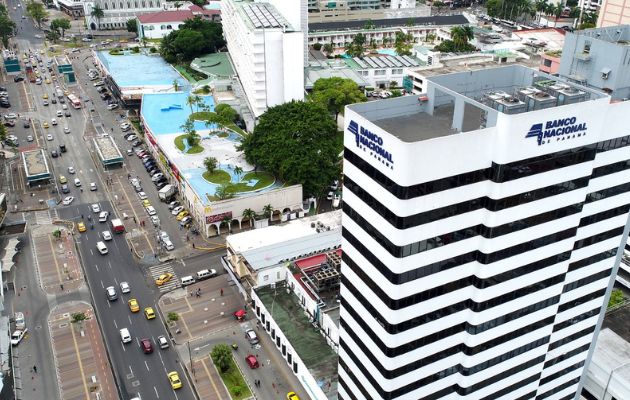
[343,176,590,229]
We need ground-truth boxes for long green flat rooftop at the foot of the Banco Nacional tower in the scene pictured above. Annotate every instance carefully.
[256,284,338,399]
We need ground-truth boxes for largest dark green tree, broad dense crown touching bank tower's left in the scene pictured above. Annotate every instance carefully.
[239,101,341,195]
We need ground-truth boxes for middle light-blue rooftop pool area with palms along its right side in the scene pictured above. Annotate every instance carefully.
[141,92,214,135]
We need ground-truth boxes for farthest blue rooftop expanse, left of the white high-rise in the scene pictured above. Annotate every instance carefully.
[96,51,190,90]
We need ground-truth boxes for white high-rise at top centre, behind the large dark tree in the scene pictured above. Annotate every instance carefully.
[221,0,307,118]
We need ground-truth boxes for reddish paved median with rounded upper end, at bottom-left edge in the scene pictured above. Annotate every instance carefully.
[48,302,118,400]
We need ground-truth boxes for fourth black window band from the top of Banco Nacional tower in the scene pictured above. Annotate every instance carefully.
[341,222,577,284]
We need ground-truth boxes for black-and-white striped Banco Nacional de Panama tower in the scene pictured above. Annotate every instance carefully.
[339,65,630,400]
